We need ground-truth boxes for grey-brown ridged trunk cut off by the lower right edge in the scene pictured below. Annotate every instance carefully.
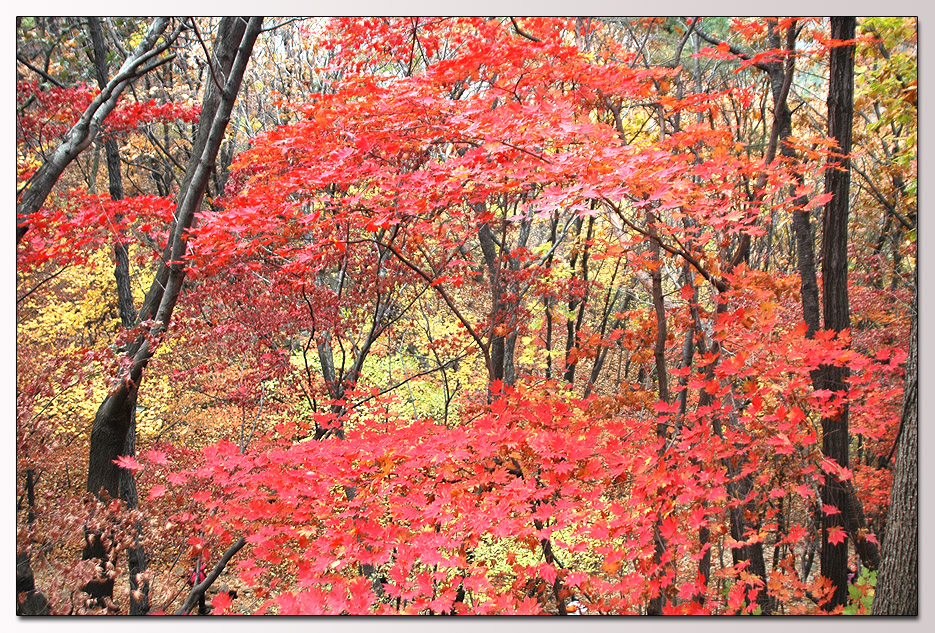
[872,295,919,615]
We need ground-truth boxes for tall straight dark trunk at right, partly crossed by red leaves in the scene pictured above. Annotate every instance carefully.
[815,17,856,609]
